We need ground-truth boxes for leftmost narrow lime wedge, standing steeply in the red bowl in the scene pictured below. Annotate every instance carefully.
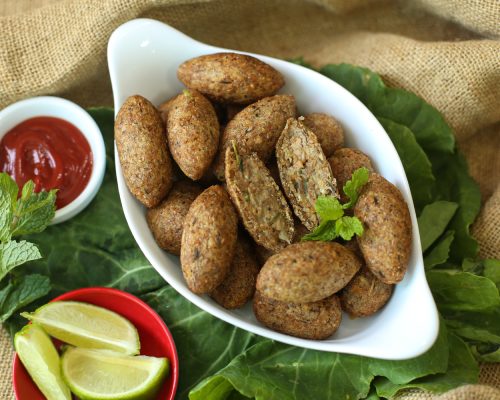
[14,324,71,400]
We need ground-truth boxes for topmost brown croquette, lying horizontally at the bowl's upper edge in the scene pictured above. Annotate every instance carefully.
[177,53,285,104]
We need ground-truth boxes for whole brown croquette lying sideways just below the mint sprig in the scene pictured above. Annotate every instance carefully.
[257,242,361,303]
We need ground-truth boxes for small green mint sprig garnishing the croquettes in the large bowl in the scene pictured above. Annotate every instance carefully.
[301,167,370,242]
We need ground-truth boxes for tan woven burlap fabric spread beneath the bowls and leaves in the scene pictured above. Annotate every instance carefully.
[0,0,500,400]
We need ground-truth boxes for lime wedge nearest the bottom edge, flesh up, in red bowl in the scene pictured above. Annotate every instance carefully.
[61,347,168,400]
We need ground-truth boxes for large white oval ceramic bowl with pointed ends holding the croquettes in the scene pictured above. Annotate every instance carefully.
[108,19,439,359]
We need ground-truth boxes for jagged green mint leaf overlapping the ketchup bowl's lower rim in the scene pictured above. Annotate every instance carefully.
[11,181,56,236]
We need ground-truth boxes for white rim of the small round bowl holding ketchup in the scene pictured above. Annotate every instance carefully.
[0,96,106,225]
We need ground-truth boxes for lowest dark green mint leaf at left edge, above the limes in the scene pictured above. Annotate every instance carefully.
[0,274,50,323]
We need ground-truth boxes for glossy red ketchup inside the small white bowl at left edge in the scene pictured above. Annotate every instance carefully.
[0,117,92,209]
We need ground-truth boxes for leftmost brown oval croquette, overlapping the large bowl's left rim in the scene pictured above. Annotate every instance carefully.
[115,95,173,207]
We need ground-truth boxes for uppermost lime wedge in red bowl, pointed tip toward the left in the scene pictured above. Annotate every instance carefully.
[21,301,141,354]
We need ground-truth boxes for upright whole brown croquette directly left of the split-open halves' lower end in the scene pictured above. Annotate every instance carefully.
[181,186,238,294]
